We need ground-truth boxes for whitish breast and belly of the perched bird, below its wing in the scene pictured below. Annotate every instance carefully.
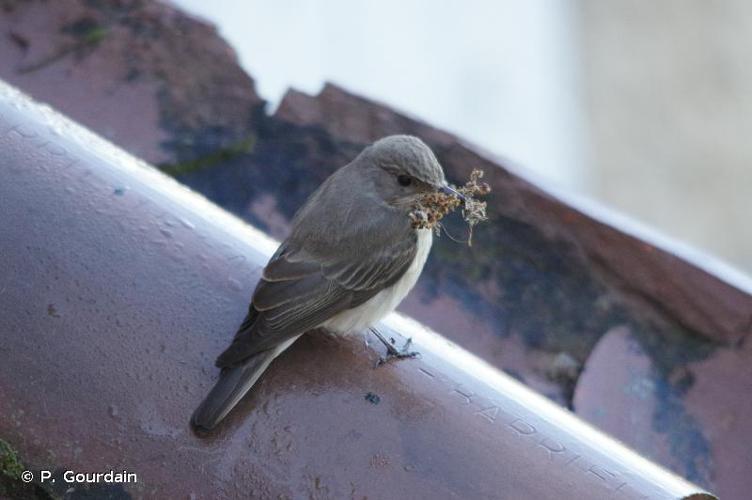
[321,229,433,334]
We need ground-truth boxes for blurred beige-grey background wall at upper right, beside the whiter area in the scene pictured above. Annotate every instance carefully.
[578,0,752,272]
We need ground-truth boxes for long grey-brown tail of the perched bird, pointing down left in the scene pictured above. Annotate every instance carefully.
[191,339,295,431]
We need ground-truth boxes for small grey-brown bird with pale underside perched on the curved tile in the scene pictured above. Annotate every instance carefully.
[192,135,462,430]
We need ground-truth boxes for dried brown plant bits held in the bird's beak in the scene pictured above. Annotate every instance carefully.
[410,169,491,246]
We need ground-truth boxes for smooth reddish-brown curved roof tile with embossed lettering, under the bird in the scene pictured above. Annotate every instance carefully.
[0,83,712,499]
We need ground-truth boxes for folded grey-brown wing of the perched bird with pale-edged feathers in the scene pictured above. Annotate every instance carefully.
[217,221,417,367]
